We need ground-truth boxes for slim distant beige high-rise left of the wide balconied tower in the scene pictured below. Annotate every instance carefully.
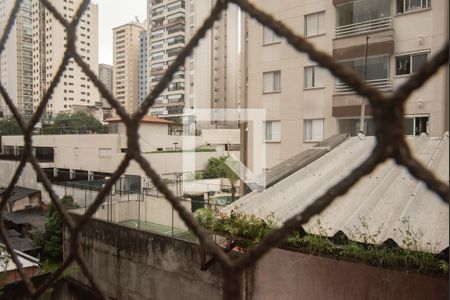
[113,22,145,113]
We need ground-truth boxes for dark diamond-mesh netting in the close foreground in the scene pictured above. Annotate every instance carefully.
[0,0,449,299]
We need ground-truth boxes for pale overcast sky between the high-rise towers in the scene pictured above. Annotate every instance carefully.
[92,0,147,65]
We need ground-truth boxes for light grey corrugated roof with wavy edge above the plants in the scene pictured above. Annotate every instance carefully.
[225,133,449,253]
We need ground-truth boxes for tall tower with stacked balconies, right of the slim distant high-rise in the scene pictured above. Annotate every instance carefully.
[147,0,240,122]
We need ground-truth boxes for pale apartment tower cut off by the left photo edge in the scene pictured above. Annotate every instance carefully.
[0,0,33,119]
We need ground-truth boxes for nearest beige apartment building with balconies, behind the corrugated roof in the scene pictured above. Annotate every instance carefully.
[244,0,449,168]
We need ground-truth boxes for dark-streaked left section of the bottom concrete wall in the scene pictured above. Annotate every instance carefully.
[65,216,222,300]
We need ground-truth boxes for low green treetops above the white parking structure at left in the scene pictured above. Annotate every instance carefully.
[43,112,108,134]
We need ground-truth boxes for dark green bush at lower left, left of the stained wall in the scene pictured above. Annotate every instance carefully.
[33,196,78,263]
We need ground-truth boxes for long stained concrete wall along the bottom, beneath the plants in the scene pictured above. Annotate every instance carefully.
[65,216,449,300]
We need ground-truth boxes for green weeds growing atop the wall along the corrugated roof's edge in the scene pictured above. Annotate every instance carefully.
[195,208,449,274]
